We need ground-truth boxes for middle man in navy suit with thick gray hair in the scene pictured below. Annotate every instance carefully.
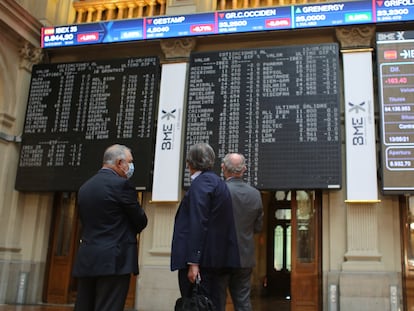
[171,143,240,311]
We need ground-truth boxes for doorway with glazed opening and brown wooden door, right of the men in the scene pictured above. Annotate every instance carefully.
[262,190,322,311]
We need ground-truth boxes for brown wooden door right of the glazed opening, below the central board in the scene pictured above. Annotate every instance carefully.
[291,191,322,311]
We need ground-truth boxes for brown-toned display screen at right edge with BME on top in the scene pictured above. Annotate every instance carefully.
[377,31,414,194]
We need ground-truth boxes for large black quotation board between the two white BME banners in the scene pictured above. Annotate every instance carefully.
[184,44,342,189]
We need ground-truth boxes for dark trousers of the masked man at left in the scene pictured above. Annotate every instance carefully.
[75,274,131,311]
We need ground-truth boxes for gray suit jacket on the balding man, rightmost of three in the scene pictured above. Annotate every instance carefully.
[226,178,263,268]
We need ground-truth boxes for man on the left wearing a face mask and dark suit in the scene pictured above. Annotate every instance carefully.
[73,145,148,311]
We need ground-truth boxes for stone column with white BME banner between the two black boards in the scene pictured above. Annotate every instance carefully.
[136,38,196,310]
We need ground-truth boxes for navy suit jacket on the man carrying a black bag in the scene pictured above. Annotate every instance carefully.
[171,171,240,271]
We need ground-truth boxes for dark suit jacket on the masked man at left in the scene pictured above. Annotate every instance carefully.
[73,168,148,277]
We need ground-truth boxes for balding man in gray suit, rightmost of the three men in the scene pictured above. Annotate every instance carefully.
[221,153,263,311]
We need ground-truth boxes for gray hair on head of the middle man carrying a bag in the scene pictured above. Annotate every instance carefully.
[187,143,216,171]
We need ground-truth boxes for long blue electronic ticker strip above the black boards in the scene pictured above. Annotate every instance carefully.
[41,0,414,48]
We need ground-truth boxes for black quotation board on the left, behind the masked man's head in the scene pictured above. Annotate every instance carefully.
[15,57,160,191]
